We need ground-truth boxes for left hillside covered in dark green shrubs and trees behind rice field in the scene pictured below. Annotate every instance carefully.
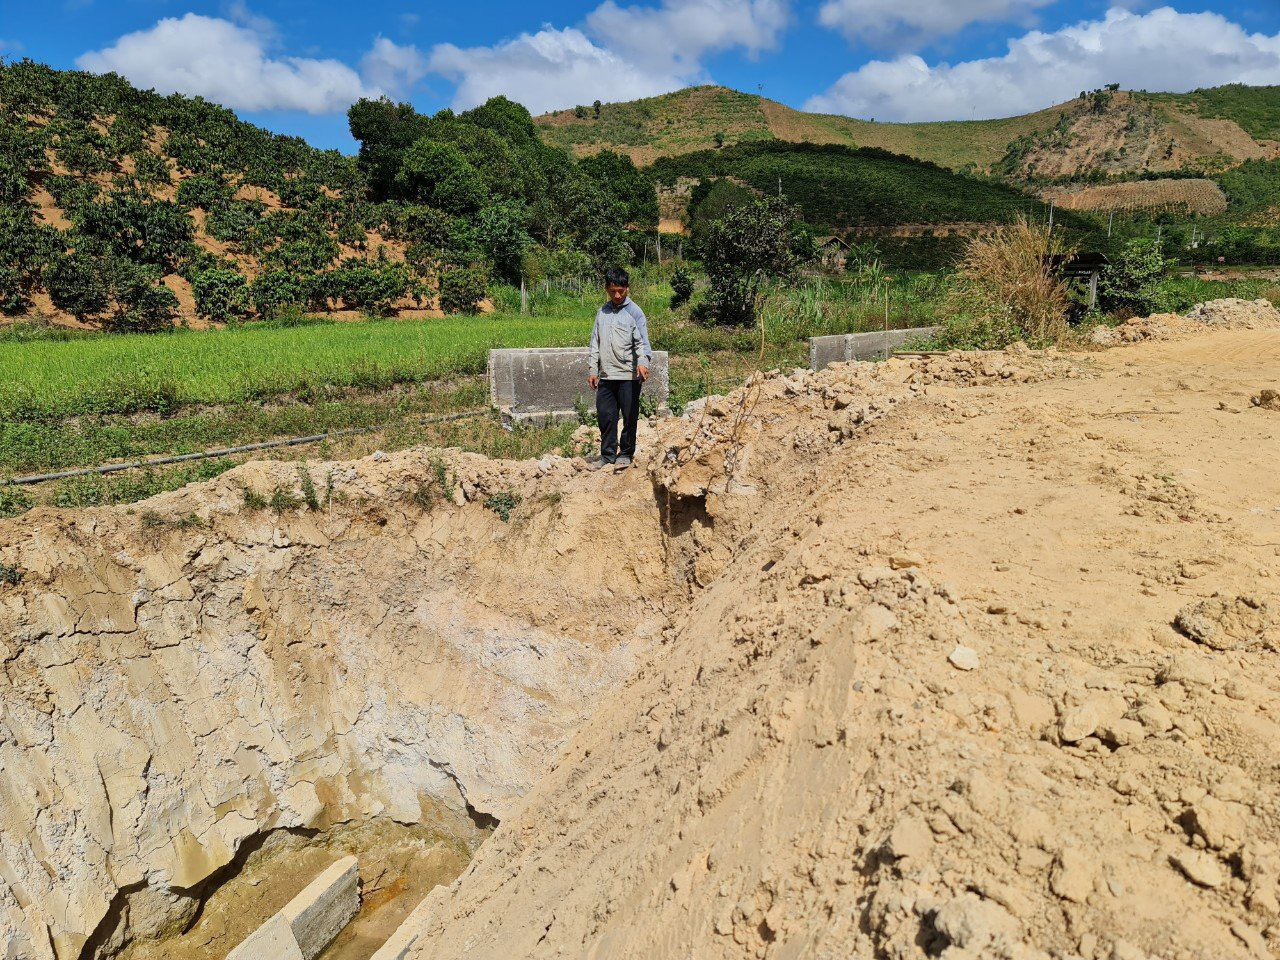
[0,61,657,330]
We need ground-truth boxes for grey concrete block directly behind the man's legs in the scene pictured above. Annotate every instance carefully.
[489,347,671,422]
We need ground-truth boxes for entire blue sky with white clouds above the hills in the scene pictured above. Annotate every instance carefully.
[0,0,1280,150]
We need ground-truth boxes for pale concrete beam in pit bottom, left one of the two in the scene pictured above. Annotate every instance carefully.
[227,856,360,960]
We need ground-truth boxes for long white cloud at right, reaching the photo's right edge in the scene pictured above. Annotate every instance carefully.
[805,6,1280,120]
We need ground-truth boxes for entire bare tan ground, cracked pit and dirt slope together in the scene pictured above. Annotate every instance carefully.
[0,305,1280,960]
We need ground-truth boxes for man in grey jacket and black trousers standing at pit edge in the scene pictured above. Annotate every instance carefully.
[586,266,653,470]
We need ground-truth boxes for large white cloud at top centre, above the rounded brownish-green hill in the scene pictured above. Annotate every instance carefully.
[430,0,790,113]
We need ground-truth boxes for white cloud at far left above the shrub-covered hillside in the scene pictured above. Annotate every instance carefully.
[76,13,425,114]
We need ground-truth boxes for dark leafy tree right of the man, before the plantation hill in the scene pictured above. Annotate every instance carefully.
[700,197,797,325]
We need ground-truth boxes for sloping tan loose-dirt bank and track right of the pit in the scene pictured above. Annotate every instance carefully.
[411,319,1280,960]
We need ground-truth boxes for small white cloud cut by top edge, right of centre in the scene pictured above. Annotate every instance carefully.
[818,0,1055,44]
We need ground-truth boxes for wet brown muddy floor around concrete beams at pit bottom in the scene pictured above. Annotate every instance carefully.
[119,809,488,960]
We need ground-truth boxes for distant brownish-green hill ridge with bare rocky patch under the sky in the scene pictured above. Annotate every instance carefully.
[536,86,1280,179]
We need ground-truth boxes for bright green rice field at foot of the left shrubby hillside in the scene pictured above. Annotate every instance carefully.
[0,311,591,421]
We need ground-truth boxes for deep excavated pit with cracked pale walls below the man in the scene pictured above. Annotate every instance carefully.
[0,453,682,960]
